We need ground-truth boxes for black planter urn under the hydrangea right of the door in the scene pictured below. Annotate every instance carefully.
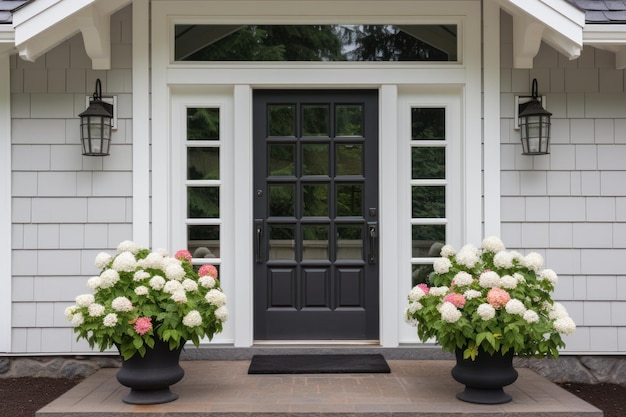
[452,349,518,404]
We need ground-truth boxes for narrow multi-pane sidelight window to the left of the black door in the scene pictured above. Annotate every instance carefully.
[185,107,221,263]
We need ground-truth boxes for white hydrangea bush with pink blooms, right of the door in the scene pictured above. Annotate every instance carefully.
[405,237,576,359]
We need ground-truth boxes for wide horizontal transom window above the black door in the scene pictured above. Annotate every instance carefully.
[174,25,458,62]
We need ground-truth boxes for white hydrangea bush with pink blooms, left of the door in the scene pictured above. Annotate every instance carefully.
[65,241,228,359]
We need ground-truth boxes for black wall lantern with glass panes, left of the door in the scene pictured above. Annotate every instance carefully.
[78,78,113,156]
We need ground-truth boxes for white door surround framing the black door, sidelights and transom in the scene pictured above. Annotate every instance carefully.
[151,0,481,347]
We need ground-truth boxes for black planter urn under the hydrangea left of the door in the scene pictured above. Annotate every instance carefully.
[116,339,185,404]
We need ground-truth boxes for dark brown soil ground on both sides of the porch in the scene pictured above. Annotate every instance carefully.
[0,378,626,417]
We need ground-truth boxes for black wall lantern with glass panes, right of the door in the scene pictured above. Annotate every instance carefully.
[518,78,552,155]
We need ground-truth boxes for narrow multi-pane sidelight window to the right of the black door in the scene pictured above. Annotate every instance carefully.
[410,107,448,286]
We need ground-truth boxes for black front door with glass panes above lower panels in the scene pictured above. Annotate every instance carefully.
[253,90,379,340]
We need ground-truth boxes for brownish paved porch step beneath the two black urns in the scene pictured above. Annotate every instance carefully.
[36,360,602,417]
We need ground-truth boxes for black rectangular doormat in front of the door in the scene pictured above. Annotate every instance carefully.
[248,354,391,374]
